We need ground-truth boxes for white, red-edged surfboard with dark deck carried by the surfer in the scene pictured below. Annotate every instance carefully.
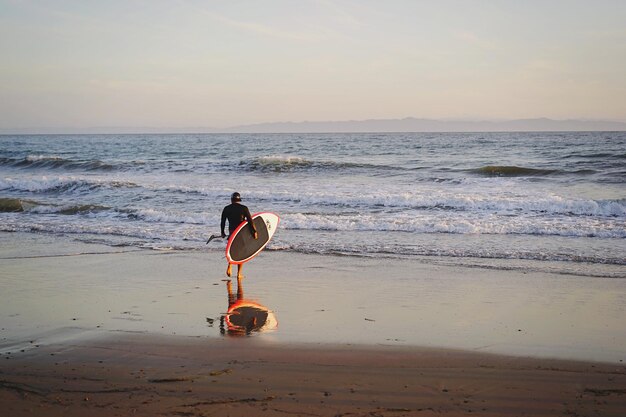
[226,212,280,265]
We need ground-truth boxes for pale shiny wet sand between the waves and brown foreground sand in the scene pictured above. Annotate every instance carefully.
[0,229,626,364]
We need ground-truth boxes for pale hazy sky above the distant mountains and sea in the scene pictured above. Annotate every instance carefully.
[0,0,626,129]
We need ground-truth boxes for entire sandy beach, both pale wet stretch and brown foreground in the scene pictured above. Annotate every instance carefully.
[0,233,626,416]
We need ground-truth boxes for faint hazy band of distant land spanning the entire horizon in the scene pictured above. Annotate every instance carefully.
[0,117,626,134]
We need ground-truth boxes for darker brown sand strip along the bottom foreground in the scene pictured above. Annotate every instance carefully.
[0,335,626,417]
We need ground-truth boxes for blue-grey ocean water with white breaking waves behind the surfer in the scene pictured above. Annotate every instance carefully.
[0,132,626,278]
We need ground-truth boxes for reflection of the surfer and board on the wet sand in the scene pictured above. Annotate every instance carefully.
[220,279,278,335]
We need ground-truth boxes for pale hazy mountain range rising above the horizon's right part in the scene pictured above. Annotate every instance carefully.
[221,117,626,133]
